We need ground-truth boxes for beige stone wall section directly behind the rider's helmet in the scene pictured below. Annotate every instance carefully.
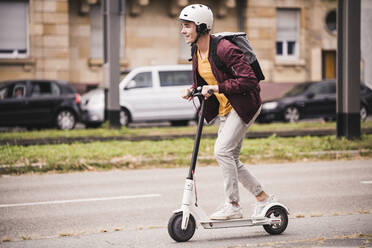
[125,1,237,67]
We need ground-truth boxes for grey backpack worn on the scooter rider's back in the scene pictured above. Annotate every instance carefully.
[192,32,265,81]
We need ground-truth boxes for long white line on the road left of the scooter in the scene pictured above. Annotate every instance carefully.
[0,194,161,208]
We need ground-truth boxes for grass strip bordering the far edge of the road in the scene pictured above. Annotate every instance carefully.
[0,135,372,174]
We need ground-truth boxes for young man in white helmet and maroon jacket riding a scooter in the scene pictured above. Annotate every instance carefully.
[179,4,273,220]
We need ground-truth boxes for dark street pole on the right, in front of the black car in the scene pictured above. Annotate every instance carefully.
[336,0,361,139]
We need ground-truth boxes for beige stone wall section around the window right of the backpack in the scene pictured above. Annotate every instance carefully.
[247,0,337,82]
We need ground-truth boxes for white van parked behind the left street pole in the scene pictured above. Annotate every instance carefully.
[82,65,199,127]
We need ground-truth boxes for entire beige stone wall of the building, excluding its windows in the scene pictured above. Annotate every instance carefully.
[0,0,337,89]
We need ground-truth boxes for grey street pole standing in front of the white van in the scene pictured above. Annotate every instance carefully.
[102,0,124,128]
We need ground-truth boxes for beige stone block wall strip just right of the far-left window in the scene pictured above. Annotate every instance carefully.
[30,0,70,80]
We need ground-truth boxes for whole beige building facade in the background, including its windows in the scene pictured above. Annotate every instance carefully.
[0,0,354,92]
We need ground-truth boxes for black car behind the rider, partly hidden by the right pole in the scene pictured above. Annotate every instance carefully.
[257,80,372,122]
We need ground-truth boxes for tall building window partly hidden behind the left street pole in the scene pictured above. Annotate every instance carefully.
[90,4,125,59]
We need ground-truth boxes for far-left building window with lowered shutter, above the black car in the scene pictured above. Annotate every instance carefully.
[0,1,28,58]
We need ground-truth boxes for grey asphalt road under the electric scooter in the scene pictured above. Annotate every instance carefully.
[0,160,372,248]
